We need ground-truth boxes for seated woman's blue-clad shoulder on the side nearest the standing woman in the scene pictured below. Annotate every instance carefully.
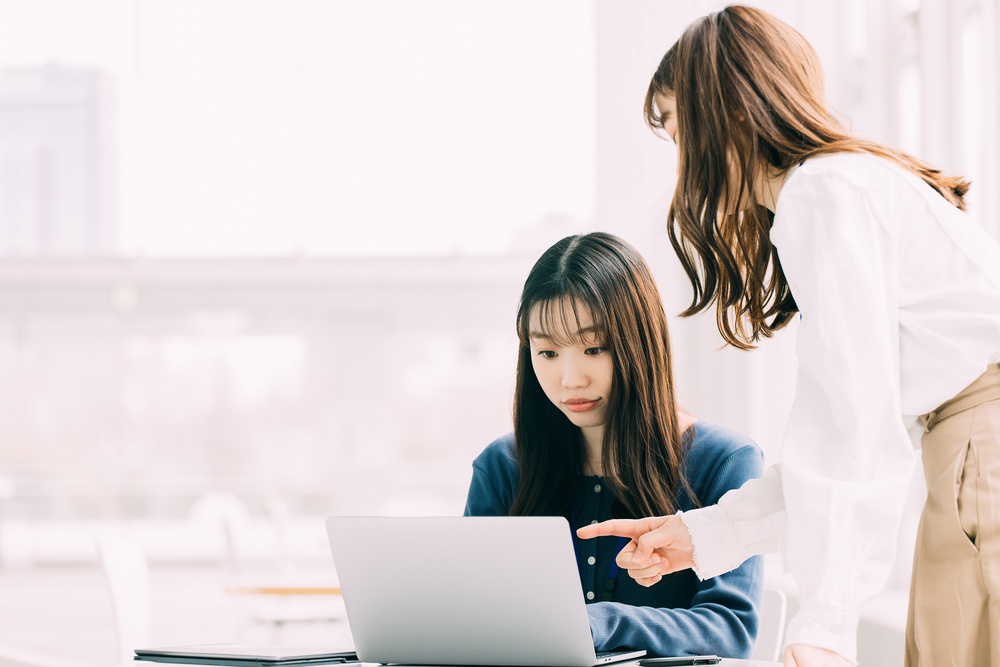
[684,420,764,504]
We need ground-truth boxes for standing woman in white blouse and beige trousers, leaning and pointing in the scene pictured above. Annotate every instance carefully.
[580,6,1000,667]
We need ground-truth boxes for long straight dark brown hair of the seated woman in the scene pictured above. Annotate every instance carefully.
[510,233,697,518]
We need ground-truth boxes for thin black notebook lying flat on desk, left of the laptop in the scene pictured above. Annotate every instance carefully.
[135,644,358,667]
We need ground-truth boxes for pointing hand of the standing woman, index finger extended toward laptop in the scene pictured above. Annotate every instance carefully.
[576,516,694,586]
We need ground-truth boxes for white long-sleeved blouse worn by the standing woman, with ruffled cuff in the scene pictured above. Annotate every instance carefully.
[682,154,1000,661]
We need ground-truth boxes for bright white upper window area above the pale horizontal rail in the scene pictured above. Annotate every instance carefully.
[0,0,595,257]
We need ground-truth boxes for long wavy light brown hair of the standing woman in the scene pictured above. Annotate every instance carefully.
[644,5,969,349]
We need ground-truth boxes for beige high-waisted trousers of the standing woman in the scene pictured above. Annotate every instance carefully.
[906,364,1000,667]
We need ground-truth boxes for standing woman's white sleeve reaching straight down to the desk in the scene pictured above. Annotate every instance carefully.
[771,172,915,660]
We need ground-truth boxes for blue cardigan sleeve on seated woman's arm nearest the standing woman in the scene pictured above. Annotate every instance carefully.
[587,447,764,658]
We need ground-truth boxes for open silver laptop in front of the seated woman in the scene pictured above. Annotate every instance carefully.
[326,517,645,667]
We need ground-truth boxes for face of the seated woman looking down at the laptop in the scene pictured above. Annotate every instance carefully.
[528,299,614,441]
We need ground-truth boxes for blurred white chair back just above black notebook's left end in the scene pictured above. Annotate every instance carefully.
[97,533,153,667]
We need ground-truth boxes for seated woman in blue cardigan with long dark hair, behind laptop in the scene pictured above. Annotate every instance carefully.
[465,233,763,658]
